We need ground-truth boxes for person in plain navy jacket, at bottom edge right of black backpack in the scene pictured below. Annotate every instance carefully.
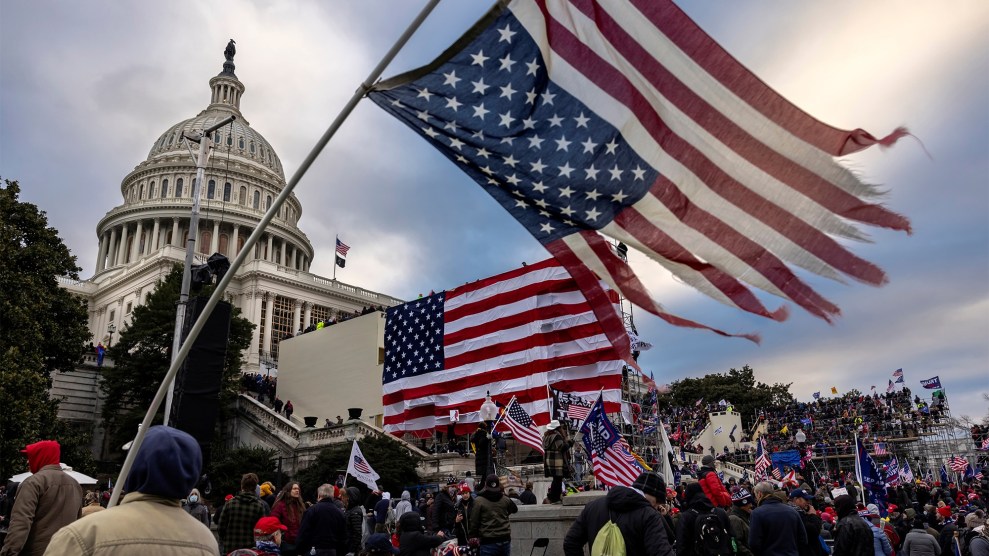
[749,481,808,556]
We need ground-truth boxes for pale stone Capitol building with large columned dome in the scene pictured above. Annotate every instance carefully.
[61,47,403,372]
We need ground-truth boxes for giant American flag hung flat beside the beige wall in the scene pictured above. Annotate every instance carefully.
[382,259,623,436]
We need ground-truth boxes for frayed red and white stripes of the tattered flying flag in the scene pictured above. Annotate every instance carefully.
[509,0,910,333]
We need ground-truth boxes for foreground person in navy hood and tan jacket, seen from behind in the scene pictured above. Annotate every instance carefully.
[44,426,219,556]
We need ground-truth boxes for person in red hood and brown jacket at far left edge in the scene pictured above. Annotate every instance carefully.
[0,440,82,556]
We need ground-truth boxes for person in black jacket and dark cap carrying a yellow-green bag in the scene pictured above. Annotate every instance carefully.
[563,472,673,556]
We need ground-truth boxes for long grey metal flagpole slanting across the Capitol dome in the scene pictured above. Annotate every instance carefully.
[107,0,439,507]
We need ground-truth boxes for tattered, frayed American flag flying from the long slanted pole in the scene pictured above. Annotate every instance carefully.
[369,0,910,340]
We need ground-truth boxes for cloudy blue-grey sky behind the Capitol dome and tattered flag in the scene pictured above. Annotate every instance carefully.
[0,0,989,417]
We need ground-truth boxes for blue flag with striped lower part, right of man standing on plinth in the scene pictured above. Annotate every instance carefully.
[580,390,643,486]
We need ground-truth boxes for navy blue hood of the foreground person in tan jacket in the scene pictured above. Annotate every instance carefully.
[124,425,203,500]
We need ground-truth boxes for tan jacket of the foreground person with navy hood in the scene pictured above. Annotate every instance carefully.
[45,492,220,556]
